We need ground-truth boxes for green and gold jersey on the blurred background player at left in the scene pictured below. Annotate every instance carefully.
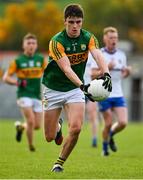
[8,54,47,99]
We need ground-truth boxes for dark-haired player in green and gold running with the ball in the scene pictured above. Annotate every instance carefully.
[43,4,112,172]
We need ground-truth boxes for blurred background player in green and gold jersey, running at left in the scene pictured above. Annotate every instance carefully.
[3,34,47,151]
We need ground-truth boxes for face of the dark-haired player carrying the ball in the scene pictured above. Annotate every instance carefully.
[64,17,83,38]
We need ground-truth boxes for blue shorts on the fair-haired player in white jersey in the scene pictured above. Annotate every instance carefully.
[98,97,126,111]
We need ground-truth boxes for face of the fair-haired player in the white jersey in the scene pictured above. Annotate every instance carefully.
[104,32,118,50]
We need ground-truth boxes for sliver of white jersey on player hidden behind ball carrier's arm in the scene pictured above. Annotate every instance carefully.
[83,52,96,84]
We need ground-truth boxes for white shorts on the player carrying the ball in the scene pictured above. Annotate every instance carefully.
[43,87,85,111]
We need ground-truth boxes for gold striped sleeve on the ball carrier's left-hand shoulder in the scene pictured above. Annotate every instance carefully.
[49,40,66,61]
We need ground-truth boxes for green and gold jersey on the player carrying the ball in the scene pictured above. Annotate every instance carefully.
[42,29,98,92]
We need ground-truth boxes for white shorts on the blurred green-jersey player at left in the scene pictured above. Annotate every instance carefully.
[17,97,42,112]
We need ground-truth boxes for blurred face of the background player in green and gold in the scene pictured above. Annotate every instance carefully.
[23,38,38,56]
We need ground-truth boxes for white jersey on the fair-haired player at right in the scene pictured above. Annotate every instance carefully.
[101,48,127,97]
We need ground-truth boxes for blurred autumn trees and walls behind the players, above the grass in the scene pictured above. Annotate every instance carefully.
[0,0,143,121]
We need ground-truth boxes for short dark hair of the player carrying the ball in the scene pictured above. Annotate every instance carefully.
[64,4,83,19]
